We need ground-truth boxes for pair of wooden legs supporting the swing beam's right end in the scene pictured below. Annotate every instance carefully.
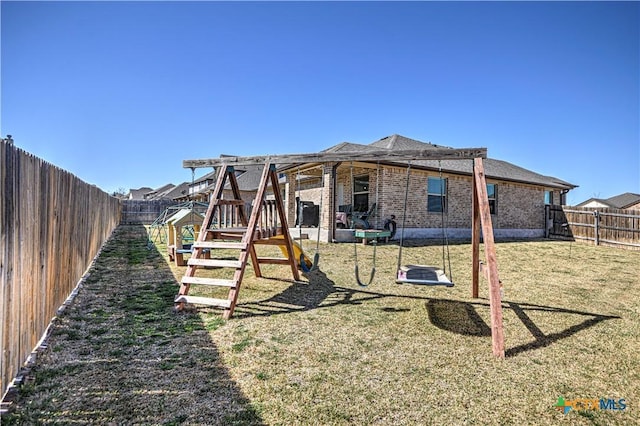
[471,158,504,358]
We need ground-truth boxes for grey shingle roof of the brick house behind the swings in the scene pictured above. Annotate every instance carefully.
[323,135,577,189]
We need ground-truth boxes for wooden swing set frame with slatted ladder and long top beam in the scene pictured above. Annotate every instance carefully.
[175,148,504,358]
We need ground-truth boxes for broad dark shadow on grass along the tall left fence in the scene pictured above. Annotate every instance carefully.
[2,225,264,425]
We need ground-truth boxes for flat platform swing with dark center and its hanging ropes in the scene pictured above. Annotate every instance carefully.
[396,161,454,287]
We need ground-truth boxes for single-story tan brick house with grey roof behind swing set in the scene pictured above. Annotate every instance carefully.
[278,135,576,241]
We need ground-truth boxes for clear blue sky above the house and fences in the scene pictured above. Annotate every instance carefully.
[0,1,640,204]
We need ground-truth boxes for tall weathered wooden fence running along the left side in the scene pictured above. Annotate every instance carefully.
[0,140,120,396]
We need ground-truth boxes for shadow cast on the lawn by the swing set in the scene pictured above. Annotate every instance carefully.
[234,271,620,357]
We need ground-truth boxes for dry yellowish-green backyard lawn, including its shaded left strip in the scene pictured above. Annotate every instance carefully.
[3,227,640,425]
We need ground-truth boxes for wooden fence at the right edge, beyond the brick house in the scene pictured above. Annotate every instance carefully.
[545,205,640,249]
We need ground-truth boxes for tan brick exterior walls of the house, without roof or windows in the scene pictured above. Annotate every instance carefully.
[288,165,560,238]
